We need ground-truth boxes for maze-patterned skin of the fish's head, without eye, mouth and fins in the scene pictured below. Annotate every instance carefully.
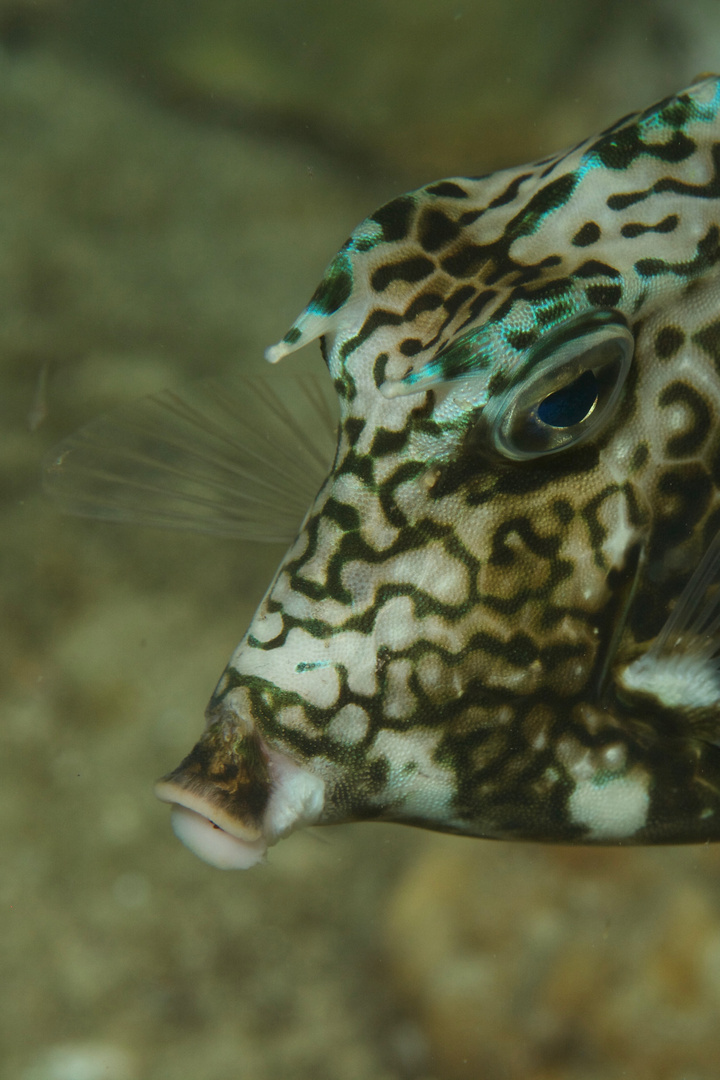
[198,80,720,842]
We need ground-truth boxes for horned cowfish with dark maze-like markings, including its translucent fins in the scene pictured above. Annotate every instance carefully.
[47,78,720,867]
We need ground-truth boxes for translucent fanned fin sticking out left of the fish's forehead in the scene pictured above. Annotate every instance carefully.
[43,370,338,543]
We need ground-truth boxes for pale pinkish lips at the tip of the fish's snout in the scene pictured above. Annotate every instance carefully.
[155,780,268,870]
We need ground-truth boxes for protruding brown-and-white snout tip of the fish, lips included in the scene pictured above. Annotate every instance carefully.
[155,719,325,869]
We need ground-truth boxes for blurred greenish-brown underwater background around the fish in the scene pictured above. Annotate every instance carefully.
[0,0,720,1080]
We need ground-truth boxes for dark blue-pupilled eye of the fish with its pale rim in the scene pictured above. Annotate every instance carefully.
[485,311,634,461]
